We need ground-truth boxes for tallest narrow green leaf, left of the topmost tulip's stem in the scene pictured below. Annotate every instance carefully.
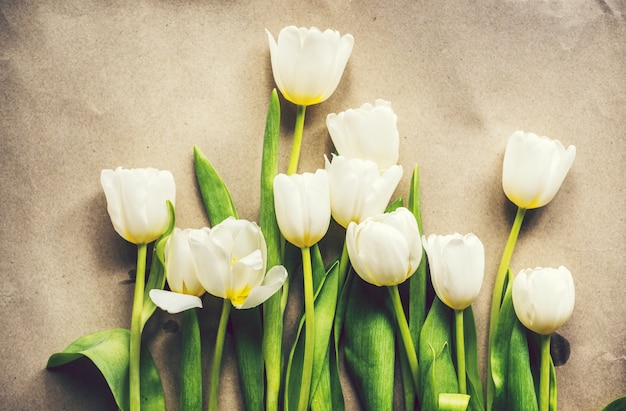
[259,89,283,411]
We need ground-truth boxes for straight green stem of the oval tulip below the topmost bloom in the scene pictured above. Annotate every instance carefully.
[298,247,315,411]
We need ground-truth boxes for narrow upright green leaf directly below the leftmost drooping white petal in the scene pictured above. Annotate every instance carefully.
[180,309,202,411]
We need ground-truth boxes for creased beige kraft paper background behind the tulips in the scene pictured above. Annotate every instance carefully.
[0,0,626,410]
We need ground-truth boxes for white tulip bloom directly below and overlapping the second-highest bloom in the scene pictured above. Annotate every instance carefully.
[325,155,402,228]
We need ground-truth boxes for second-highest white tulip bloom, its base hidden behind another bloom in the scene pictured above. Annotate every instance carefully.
[326,99,400,169]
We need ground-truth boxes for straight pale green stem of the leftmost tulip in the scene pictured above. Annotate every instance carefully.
[129,244,148,411]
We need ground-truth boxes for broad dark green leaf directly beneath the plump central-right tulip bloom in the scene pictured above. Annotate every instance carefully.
[343,278,395,411]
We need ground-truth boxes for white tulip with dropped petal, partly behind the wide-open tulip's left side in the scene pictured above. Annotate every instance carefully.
[150,228,210,314]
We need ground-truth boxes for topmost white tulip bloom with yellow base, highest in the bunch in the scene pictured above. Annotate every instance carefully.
[265,26,354,106]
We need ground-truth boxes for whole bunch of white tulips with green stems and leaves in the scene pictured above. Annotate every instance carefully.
[47,26,625,411]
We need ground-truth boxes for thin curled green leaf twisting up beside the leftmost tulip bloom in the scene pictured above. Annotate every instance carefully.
[141,200,176,330]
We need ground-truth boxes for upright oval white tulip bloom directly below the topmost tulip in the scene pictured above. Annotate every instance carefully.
[274,170,330,248]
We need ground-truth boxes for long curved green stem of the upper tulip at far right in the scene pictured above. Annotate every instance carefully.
[487,207,526,410]
